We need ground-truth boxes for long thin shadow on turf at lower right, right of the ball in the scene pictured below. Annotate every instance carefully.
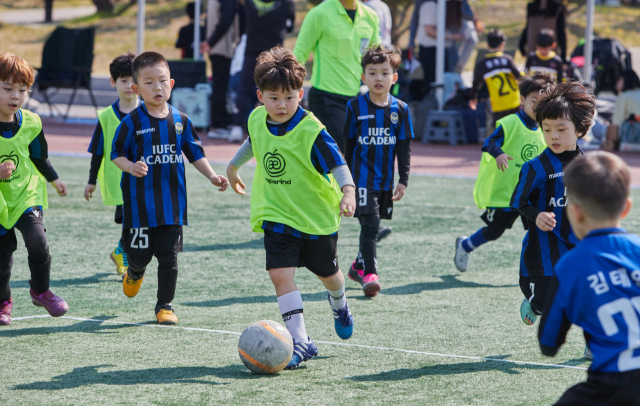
[345,355,560,382]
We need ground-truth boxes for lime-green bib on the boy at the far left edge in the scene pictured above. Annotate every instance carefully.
[0,109,48,229]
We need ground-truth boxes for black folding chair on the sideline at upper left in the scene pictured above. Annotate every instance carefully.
[34,27,98,119]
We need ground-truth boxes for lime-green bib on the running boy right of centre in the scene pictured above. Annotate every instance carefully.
[473,114,547,209]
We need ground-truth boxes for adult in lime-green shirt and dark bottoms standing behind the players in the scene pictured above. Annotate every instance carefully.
[293,0,380,152]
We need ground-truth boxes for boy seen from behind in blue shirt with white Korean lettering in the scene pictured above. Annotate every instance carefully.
[538,151,640,406]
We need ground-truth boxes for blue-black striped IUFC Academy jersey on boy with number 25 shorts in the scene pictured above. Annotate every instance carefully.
[111,105,204,228]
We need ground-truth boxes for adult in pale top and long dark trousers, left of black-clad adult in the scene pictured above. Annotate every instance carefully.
[200,0,242,138]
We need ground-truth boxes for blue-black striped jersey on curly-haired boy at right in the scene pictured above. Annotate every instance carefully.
[511,148,582,276]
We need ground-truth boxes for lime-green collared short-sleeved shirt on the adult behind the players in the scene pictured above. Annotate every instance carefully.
[293,0,380,97]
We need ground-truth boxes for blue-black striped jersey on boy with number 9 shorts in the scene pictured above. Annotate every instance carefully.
[344,93,413,190]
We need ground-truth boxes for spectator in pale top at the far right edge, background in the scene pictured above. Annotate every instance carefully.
[602,70,640,151]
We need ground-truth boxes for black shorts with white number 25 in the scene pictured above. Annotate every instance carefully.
[122,225,182,268]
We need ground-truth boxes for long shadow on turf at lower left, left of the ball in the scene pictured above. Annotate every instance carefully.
[13,364,265,390]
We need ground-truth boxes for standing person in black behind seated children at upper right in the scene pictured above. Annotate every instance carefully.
[519,0,567,63]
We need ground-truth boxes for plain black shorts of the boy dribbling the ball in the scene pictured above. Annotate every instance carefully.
[264,230,340,278]
